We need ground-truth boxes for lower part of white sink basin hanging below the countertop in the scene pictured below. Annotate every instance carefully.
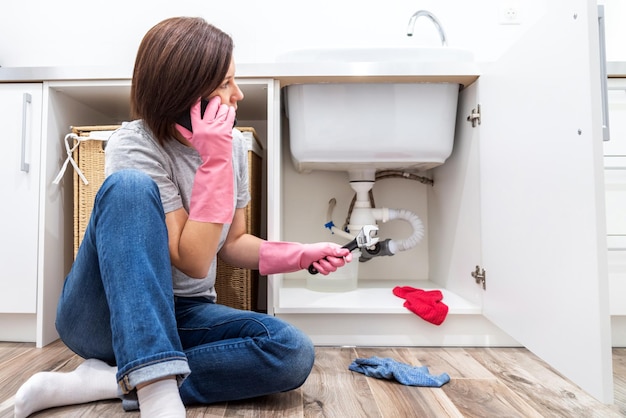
[285,83,459,172]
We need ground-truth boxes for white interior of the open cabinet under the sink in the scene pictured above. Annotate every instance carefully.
[269,78,519,346]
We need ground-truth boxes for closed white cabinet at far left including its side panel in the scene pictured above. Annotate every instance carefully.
[0,82,72,347]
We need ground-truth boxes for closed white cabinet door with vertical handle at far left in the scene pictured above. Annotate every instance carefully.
[0,84,43,313]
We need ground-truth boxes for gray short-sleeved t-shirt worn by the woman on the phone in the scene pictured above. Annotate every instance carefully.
[105,120,250,300]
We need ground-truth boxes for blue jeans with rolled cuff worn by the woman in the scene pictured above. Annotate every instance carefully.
[56,170,314,404]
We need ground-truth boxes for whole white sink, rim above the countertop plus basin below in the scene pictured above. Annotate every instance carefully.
[277,46,477,172]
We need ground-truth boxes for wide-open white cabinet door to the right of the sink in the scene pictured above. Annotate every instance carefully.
[478,0,613,403]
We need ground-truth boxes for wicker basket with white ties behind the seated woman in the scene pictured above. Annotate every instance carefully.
[72,125,262,310]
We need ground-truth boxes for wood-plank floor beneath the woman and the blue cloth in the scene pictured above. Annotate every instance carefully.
[0,341,626,418]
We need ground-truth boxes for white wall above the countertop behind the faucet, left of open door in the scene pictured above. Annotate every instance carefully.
[0,0,548,67]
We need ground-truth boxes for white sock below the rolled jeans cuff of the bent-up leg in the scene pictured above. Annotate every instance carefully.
[137,379,186,418]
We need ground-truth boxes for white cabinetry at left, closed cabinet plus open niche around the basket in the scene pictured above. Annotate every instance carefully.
[0,79,275,346]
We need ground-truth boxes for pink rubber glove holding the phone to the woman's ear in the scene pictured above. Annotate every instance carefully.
[176,96,235,224]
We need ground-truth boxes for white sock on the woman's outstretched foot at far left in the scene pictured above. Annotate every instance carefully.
[15,359,118,418]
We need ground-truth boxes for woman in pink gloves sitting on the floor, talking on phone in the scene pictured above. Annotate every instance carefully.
[15,18,352,418]
